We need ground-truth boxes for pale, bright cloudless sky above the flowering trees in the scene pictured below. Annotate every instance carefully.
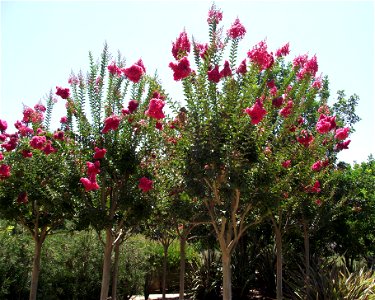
[0,0,375,163]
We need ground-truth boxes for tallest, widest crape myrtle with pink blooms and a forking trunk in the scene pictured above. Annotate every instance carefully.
[169,6,358,299]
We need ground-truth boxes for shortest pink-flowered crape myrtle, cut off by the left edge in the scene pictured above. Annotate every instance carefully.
[0,96,80,299]
